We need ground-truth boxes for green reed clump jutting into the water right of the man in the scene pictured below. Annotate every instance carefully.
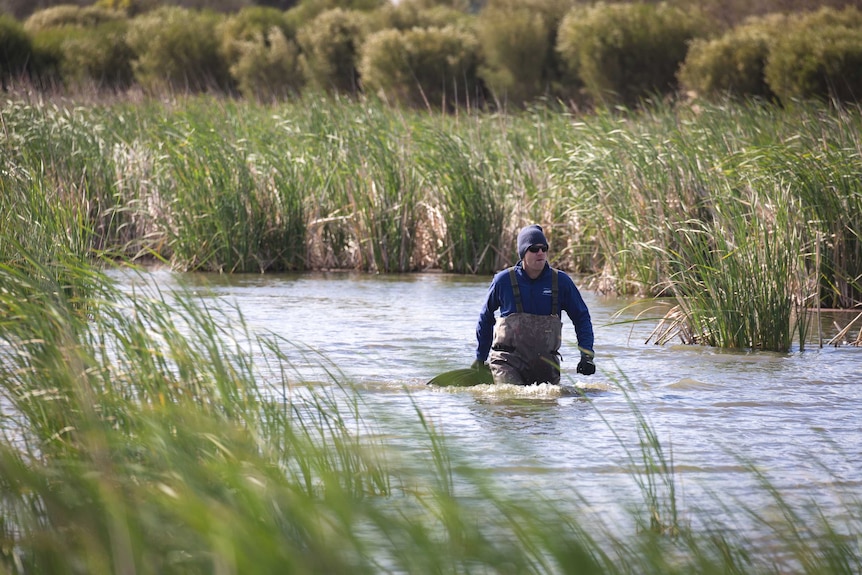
[662,181,808,351]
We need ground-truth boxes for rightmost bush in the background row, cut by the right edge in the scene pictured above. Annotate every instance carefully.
[765,8,862,104]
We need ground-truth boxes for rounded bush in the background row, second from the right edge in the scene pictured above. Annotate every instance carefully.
[679,14,787,98]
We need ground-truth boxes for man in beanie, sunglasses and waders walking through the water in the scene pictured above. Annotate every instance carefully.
[473,224,596,385]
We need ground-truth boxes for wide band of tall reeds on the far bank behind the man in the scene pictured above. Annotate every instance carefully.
[0,96,862,350]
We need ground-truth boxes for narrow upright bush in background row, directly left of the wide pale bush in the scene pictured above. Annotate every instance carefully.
[299,8,367,94]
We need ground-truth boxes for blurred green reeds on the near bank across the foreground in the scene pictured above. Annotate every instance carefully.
[0,258,862,575]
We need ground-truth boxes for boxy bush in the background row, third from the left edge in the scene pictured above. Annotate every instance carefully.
[128,8,230,92]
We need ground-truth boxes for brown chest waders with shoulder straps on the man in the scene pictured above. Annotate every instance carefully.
[488,268,563,385]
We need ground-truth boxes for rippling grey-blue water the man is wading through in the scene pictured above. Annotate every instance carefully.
[109,271,862,540]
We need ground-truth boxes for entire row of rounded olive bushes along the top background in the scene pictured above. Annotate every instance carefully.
[0,0,862,111]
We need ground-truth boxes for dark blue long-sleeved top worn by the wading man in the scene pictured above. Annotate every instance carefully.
[476,262,593,362]
